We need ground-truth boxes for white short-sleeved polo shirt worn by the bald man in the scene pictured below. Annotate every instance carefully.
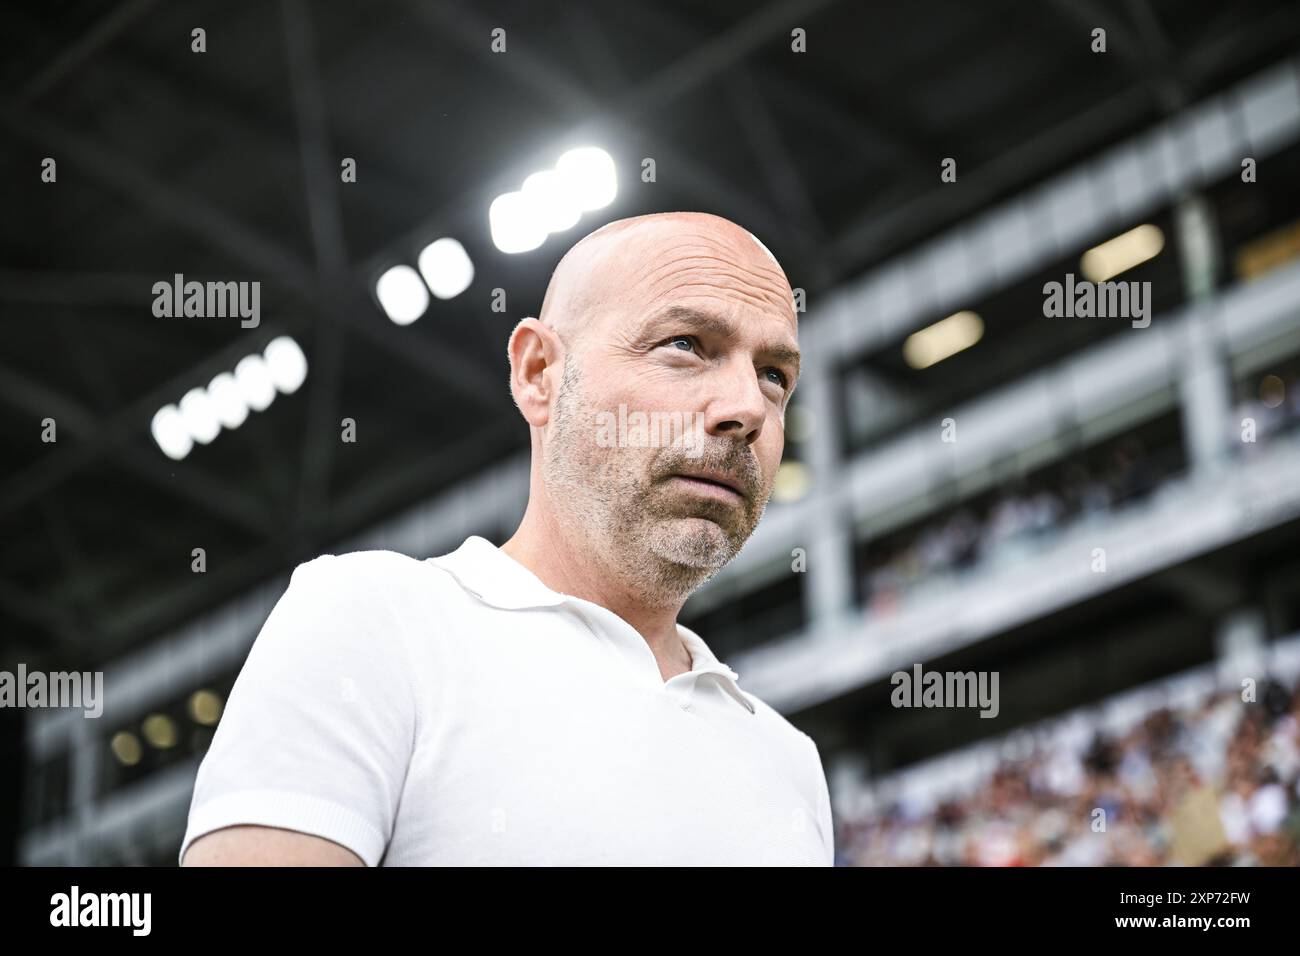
[179,537,833,866]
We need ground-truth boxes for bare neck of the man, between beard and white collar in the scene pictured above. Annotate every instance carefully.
[501,502,692,680]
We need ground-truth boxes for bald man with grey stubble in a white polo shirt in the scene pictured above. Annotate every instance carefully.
[179,212,833,866]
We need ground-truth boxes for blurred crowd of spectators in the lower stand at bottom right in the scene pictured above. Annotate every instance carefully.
[836,682,1300,866]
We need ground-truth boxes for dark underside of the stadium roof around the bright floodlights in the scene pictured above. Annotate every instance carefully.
[0,0,1300,667]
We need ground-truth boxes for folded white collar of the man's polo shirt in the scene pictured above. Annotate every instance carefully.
[428,535,754,714]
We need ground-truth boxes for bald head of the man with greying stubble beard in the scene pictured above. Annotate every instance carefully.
[510,212,798,605]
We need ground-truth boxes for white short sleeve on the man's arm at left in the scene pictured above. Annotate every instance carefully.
[178,551,417,866]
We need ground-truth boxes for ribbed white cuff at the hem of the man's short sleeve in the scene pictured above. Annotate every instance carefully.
[177,790,385,866]
